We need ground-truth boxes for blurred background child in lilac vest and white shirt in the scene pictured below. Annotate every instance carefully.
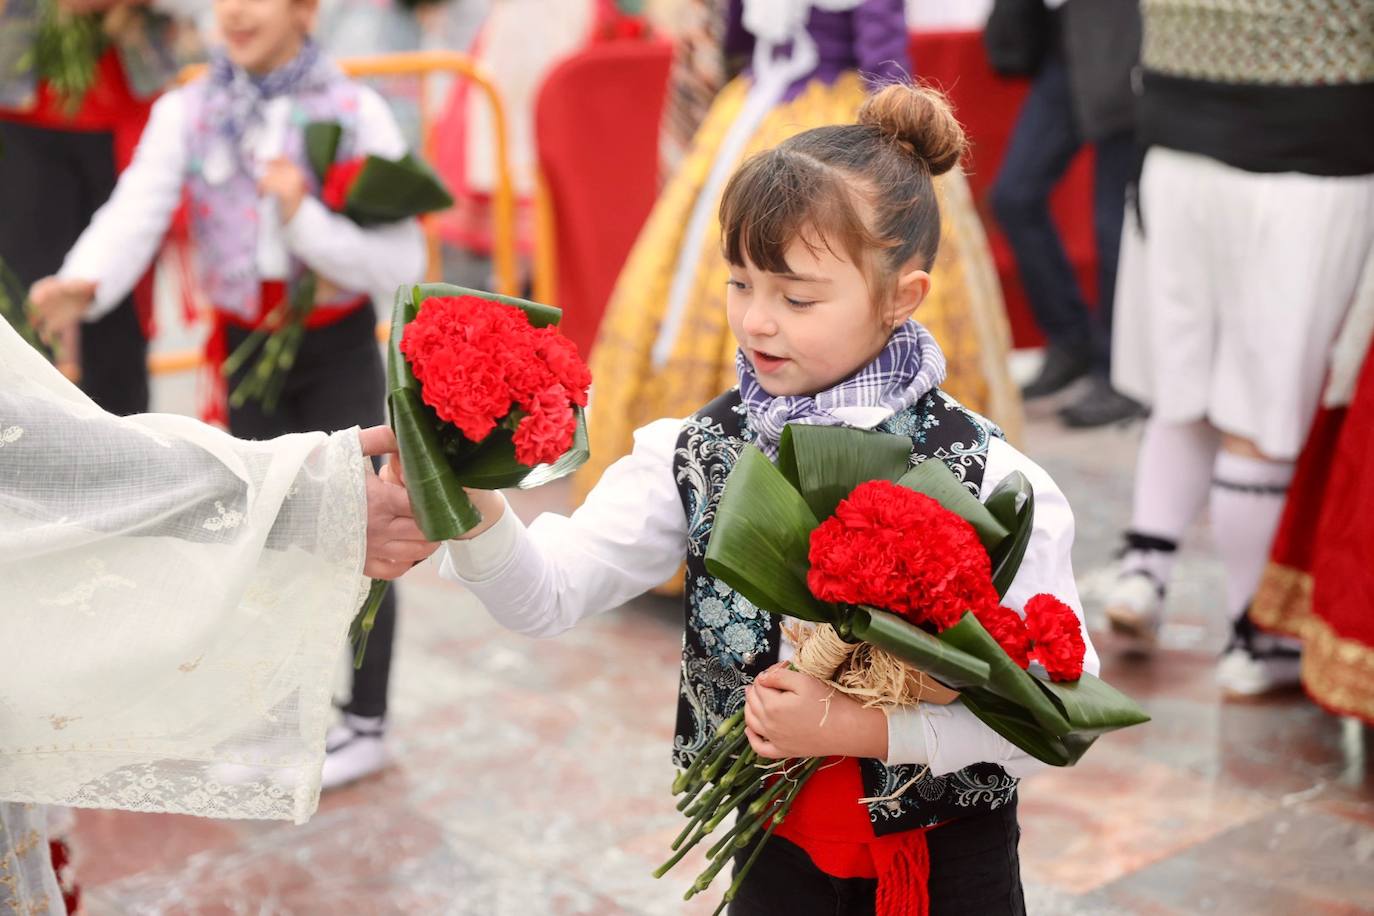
[32,0,425,787]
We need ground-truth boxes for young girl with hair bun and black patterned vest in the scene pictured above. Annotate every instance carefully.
[444,85,1098,916]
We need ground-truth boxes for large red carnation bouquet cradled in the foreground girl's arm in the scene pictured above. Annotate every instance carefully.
[657,426,1149,912]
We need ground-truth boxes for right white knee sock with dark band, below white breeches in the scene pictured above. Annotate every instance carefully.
[1212,452,1293,622]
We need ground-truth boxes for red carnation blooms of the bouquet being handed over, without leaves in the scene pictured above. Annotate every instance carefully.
[400,295,592,467]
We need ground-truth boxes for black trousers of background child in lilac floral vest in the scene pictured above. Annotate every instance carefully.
[227,305,396,715]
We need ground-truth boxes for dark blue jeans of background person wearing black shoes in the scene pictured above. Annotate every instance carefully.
[992,49,1139,374]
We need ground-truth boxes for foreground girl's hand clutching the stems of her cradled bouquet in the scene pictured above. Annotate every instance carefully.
[745,663,888,759]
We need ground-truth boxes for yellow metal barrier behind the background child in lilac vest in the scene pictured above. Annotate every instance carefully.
[148,51,519,375]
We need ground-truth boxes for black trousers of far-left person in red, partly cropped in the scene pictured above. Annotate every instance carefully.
[0,119,148,416]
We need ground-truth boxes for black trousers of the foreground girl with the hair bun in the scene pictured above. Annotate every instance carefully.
[728,801,1026,916]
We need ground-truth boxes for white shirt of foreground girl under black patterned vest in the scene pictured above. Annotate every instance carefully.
[441,409,1099,777]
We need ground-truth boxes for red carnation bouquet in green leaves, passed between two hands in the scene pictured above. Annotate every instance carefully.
[352,283,592,663]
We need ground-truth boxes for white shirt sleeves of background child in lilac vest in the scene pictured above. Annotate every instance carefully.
[58,87,425,321]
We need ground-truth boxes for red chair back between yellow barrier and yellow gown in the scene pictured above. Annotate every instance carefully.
[534,38,673,353]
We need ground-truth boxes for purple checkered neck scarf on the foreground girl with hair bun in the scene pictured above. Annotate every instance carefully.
[735,321,945,459]
